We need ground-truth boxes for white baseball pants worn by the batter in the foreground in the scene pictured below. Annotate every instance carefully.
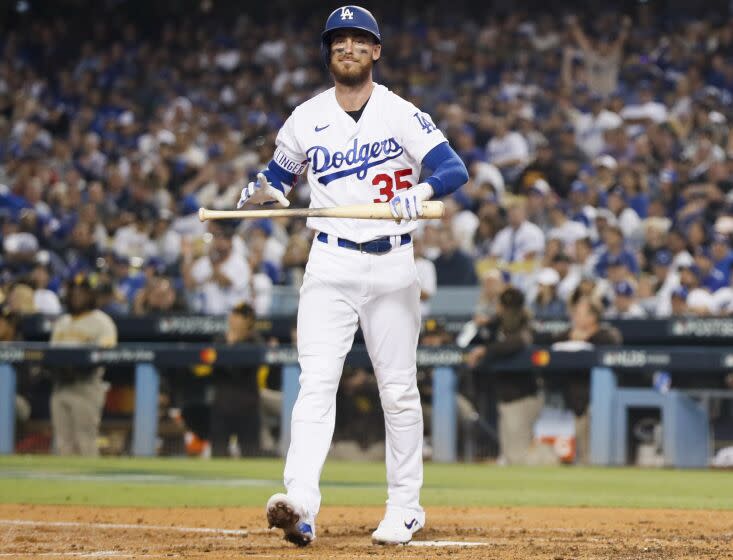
[285,240,423,517]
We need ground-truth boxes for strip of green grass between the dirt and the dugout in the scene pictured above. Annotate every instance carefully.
[0,456,733,509]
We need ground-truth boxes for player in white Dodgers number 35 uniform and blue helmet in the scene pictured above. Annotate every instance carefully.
[238,6,468,546]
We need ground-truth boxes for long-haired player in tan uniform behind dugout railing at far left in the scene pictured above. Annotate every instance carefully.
[51,274,117,456]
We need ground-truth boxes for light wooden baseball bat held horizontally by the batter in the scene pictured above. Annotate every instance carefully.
[199,200,443,222]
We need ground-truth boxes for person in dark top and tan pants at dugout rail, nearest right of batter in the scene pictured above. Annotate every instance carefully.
[466,286,542,465]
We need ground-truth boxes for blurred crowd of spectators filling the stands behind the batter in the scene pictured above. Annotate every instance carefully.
[0,7,733,318]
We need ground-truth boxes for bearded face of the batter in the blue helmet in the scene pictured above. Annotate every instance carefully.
[330,29,382,86]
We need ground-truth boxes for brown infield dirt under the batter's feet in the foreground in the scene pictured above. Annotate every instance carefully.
[0,505,733,560]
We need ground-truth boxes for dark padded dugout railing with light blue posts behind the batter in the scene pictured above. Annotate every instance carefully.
[0,342,733,467]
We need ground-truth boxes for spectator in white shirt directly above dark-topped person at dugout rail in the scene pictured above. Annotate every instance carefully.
[491,198,545,290]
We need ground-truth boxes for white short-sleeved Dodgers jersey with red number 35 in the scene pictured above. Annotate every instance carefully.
[273,84,446,243]
